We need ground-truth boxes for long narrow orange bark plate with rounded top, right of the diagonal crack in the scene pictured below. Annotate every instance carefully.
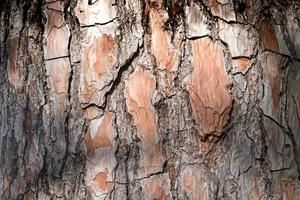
[124,71,163,173]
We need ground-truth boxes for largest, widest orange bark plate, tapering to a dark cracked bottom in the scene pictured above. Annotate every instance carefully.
[188,38,231,136]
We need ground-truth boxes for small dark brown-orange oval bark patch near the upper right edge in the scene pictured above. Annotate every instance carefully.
[260,22,279,52]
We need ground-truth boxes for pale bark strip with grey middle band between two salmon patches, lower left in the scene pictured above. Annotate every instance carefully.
[85,112,116,196]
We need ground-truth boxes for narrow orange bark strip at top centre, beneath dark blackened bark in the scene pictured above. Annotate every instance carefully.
[150,9,175,71]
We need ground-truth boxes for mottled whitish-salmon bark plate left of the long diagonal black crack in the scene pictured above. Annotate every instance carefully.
[81,34,118,104]
